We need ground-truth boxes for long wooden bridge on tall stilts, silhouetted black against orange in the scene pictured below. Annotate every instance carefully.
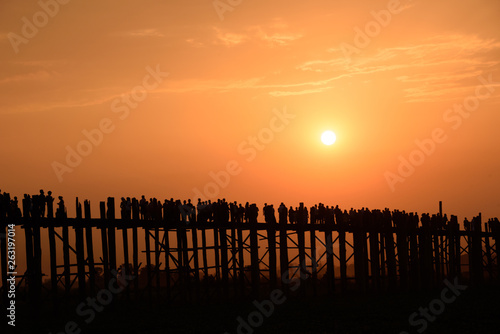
[0,194,500,310]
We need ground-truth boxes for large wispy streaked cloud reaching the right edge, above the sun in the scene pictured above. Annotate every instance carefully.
[297,35,500,102]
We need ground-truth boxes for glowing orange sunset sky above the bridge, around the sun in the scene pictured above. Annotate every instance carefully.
[0,0,500,218]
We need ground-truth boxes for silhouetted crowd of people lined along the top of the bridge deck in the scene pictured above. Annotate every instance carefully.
[0,190,500,231]
